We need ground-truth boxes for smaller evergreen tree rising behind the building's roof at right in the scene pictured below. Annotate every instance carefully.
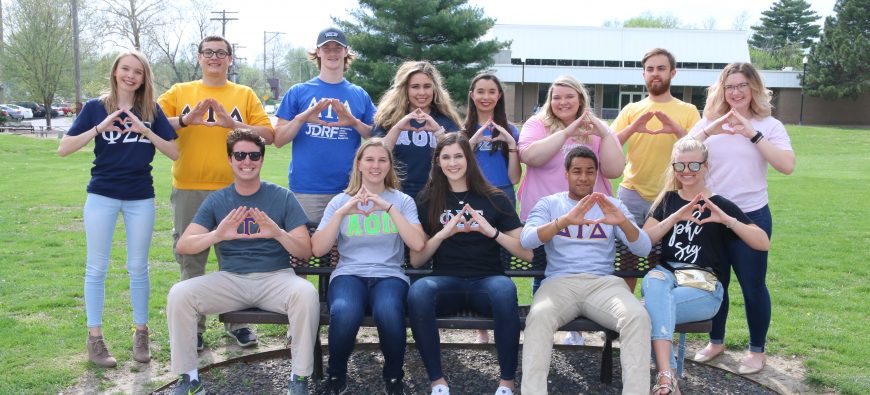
[749,0,820,50]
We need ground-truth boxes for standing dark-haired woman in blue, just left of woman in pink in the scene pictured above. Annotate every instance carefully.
[463,73,522,205]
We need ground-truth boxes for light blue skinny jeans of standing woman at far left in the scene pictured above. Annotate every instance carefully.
[84,193,154,328]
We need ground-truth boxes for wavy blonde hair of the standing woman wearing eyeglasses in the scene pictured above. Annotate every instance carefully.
[704,62,773,120]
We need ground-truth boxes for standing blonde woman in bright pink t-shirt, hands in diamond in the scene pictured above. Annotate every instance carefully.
[517,76,625,221]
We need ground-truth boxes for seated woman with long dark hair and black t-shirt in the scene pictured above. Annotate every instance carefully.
[408,133,532,394]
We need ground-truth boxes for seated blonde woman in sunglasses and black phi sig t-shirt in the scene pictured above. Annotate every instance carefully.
[642,138,770,395]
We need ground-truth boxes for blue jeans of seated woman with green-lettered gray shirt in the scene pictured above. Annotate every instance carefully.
[327,275,408,381]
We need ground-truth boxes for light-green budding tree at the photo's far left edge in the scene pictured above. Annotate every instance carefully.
[0,0,73,127]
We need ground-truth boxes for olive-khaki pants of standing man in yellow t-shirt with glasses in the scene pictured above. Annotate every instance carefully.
[169,188,248,333]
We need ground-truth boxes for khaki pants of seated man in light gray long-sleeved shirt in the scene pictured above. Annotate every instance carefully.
[522,274,650,395]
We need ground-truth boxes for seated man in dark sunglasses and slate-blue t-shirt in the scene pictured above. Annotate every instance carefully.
[166,130,320,395]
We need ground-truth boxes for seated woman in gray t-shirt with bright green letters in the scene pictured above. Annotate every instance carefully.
[311,138,426,395]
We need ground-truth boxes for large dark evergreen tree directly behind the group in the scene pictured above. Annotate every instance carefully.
[334,0,509,104]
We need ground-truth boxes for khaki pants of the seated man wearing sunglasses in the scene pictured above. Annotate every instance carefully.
[166,269,320,376]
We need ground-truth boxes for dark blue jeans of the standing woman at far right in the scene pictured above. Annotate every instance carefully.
[710,206,773,352]
